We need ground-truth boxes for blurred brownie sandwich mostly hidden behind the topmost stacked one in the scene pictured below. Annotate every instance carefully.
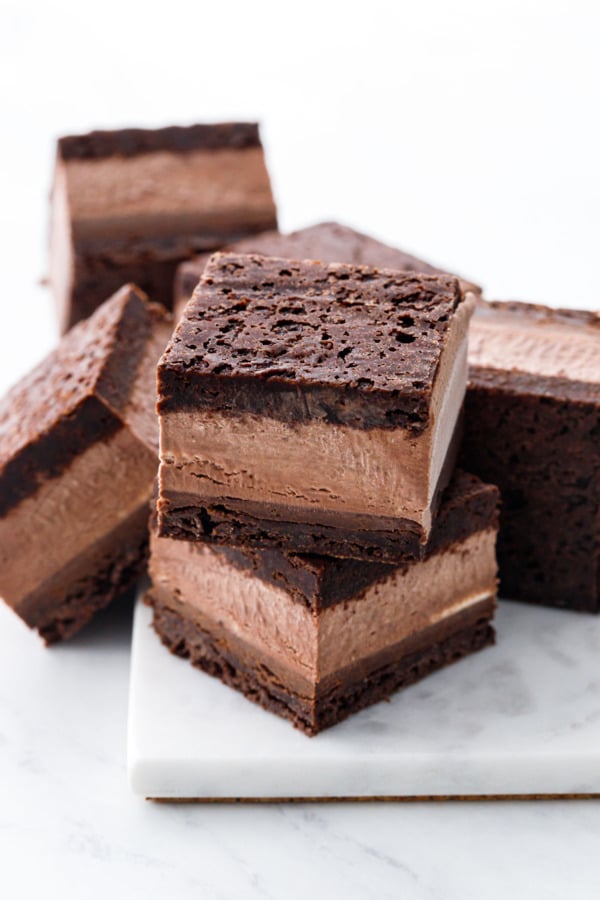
[174,222,481,319]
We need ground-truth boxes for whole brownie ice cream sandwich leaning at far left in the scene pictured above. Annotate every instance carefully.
[0,286,172,644]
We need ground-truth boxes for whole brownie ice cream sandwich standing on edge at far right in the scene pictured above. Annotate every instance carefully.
[462,303,600,612]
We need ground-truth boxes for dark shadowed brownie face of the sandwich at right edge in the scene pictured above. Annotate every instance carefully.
[460,379,600,613]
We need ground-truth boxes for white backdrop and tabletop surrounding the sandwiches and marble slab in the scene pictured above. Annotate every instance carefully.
[0,0,600,900]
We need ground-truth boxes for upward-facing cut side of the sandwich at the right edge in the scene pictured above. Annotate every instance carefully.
[469,301,600,403]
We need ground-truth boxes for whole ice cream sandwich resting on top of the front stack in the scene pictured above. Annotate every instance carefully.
[158,254,474,562]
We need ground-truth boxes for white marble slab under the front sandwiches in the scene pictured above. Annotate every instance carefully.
[128,601,600,799]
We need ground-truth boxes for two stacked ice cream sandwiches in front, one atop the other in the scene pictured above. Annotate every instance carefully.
[149,253,497,734]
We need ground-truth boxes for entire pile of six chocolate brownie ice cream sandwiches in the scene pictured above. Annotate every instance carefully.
[0,123,600,735]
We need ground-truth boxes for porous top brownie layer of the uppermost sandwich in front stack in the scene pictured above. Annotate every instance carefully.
[159,248,463,430]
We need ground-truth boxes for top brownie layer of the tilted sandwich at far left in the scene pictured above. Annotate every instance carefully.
[0,286,168,515]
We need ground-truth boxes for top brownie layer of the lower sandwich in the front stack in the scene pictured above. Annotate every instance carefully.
[213,470,499,610]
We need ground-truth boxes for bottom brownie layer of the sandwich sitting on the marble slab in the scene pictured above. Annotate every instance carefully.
[149,595,494,736]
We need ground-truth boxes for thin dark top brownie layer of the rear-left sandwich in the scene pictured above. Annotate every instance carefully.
[58,122,260,160]
